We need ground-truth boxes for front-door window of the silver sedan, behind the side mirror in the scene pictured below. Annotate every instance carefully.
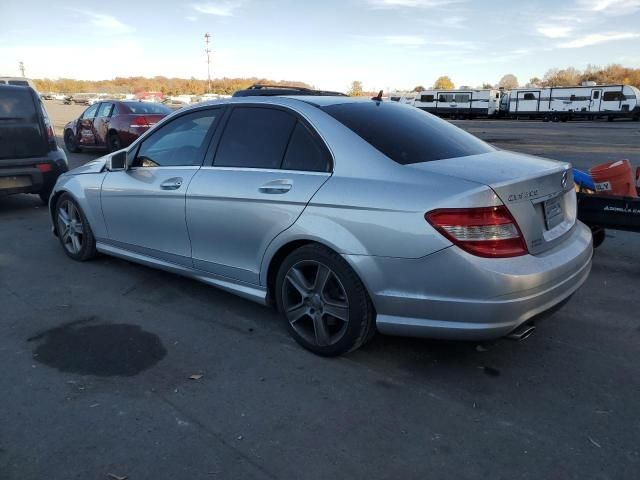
[132,109,221,167]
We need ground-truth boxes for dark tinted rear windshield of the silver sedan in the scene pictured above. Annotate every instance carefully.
[322,101,495,165]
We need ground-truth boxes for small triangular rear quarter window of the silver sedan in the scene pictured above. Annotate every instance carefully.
[282,122,331,172]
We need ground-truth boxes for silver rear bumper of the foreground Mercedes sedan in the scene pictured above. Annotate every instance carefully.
[345,223,593,340]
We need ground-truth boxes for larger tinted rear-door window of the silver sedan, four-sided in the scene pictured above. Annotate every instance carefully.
[214,107,296,169]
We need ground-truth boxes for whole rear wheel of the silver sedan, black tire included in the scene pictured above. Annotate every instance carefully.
[275,244,375,357]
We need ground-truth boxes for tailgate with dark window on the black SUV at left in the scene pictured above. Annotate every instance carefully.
[0,87,49,161]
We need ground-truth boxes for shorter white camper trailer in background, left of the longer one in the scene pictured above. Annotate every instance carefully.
[413,89,502,118]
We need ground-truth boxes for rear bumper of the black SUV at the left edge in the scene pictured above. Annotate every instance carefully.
[0,148,69,195]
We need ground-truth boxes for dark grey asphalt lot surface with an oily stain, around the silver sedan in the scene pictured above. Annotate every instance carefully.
[0,102,640,480]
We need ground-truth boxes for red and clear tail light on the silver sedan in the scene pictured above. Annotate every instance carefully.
[424,205,528,258]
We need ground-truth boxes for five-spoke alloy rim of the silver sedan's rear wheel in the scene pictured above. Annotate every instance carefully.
[282,260,349,347]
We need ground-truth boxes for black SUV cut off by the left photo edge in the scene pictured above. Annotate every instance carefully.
[0,85,68,203]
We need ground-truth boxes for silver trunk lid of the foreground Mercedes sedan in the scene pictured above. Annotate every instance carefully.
[411,151,577,255]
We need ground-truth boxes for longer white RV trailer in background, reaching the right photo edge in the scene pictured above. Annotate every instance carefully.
[500,85,640,122]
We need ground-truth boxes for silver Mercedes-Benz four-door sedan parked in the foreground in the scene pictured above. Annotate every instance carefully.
[50,96,592,355]
